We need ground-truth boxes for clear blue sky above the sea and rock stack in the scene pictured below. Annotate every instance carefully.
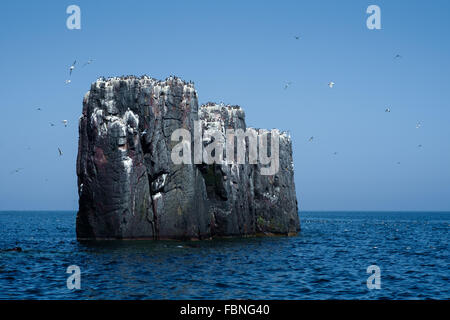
[0,0,450,210]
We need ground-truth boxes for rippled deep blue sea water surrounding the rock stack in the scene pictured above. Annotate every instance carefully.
[0,212,450,299]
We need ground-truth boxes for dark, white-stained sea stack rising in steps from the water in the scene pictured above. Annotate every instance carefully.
[76,76,300,240]
